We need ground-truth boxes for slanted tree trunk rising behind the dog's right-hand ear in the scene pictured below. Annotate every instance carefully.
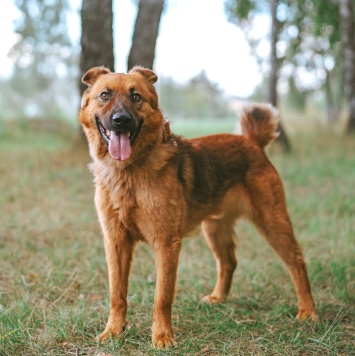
[127,0,164,70]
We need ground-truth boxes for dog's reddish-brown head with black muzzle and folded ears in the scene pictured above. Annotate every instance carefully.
[80,67,164,161]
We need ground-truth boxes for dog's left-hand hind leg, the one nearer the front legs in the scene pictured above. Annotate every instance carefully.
[202,216,237,304]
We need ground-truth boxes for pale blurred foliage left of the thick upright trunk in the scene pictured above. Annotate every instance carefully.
[1,0,78,117]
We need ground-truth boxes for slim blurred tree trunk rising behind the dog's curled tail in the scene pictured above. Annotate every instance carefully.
[269,0,291,152]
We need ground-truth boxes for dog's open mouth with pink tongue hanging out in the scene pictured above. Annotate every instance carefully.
[96,118,141,161]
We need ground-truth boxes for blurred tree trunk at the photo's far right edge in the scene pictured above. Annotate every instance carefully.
[339,0,355,134]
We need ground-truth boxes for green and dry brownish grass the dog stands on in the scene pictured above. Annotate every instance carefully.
[0,118,355,356]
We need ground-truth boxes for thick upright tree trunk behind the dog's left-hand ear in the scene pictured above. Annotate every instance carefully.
[80,0,115,94]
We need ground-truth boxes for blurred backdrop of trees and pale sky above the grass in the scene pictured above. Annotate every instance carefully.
[0,0,355,146]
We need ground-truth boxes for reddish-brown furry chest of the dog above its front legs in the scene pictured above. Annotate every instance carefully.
[95,161,182,242]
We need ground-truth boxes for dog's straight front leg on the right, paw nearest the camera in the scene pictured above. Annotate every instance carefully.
[152,237,181,349]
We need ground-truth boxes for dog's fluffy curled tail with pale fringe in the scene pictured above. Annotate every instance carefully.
[240,103,279,148]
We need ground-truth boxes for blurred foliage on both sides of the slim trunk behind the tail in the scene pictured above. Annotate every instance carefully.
[225,0,344,118]
